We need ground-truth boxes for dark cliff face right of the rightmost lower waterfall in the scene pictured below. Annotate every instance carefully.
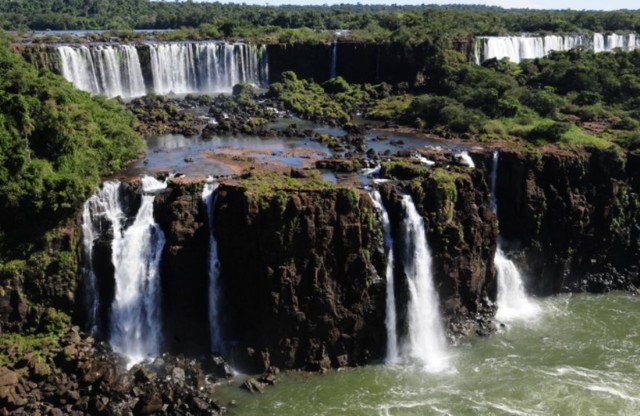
[497,149,640,294]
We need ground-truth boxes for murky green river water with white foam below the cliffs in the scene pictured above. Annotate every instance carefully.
[216,293,640,416]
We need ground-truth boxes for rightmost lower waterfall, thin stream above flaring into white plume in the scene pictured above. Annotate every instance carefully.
[490,151,539,322]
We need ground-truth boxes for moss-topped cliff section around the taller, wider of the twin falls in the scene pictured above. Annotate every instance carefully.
[381,169,498,334]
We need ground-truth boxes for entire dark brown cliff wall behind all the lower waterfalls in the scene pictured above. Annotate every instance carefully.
[10,149,640,372]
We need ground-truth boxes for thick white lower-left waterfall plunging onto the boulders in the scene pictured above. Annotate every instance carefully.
[110,176,166,365]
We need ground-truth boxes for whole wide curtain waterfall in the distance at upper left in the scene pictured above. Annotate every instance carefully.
[55,42,269,98]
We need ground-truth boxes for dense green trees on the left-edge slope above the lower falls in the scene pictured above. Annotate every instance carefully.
[0,35,141,247]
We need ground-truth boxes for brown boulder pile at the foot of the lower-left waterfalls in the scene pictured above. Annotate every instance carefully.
[0,327,231,416]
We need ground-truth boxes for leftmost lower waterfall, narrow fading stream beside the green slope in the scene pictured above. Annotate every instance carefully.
[82,182,124,336]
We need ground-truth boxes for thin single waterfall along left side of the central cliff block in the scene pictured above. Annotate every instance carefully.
[202,181,222,353]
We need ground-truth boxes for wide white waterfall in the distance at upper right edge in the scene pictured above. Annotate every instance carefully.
[475,33,640,64]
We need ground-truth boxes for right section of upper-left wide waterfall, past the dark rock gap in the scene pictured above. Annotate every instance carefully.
[149,42,268,94]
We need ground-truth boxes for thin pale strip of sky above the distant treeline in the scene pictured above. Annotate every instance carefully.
[198,0,640,10]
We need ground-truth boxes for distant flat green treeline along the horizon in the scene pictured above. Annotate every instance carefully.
[0,0,640,41]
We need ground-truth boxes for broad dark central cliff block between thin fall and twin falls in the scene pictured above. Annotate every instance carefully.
[215,185,386,371]
